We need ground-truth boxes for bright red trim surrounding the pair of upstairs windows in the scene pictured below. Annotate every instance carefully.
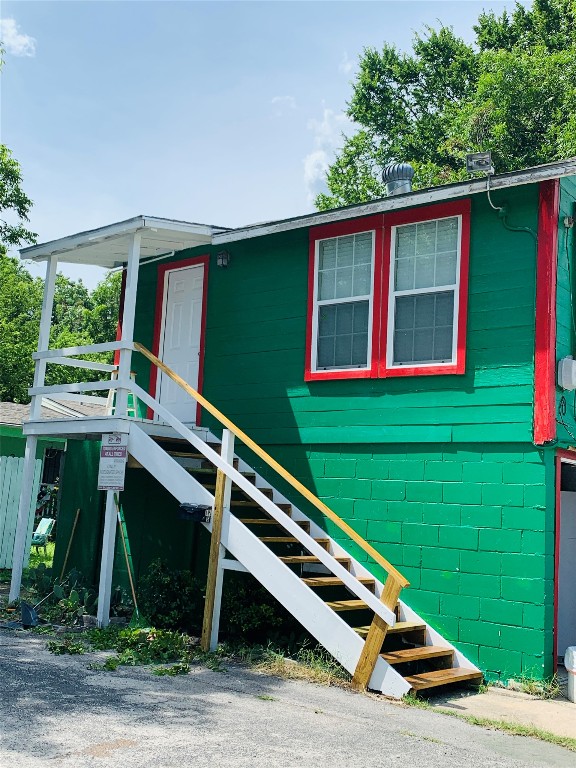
[304,199,471,381]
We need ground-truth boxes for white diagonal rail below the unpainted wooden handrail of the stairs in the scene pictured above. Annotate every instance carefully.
[132,383,396,626]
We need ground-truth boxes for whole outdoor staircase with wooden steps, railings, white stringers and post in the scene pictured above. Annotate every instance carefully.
[128,342,482,698]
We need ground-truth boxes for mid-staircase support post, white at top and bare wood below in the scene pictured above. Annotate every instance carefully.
[200,429,234,651]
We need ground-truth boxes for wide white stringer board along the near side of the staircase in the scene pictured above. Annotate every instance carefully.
[128,424,410,698]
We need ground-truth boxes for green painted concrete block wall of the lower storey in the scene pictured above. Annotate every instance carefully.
[242,444,554,679]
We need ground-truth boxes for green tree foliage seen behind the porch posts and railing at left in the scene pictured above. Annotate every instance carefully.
[0,252,122,403]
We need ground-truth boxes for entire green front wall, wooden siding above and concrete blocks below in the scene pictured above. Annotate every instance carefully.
[117,180,554,678]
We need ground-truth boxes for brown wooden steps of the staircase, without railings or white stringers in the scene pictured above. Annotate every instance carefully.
[152,441,483,691]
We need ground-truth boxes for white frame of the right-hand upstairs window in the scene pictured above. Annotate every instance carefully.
[386,214,462,370]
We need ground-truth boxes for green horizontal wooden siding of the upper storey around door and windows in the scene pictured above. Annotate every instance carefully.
[134,185,538,445]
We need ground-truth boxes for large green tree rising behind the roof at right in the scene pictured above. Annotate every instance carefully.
[316,0,576,210]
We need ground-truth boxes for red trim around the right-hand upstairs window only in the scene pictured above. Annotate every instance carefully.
[378,199,471,378]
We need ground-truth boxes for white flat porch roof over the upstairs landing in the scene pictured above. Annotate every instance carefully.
[20,216,226,268]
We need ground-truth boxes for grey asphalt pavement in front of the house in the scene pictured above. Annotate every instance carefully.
[0,630,576,768]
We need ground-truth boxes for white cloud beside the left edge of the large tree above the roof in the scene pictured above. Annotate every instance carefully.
[304,107,352,204]
